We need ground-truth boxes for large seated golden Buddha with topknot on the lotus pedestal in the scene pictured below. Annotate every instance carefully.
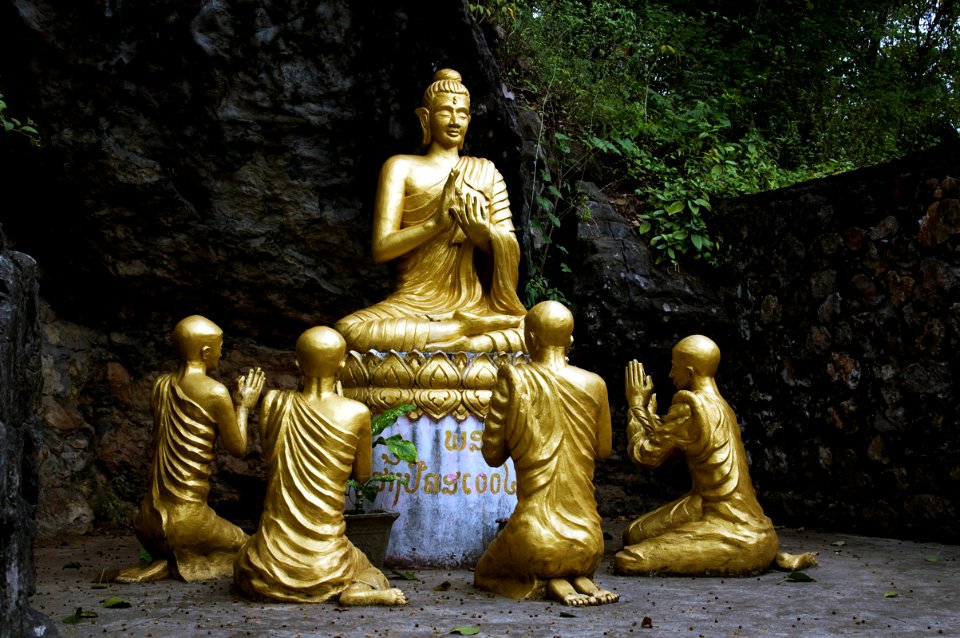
[336,69,526,352]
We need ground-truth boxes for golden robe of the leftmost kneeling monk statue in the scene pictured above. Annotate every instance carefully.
[133,374,247,581]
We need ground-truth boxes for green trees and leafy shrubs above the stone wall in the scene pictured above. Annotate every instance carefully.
[472,0,960,268]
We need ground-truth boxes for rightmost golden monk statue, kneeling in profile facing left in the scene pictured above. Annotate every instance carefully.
[614,335,816,576]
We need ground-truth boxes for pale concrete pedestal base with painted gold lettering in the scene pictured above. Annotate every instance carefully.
[373,416,517,567]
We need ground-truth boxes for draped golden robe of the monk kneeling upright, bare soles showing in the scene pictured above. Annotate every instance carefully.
[474,362,605,600]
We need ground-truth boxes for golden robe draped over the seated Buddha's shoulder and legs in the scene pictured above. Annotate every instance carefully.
[336,157,526,352]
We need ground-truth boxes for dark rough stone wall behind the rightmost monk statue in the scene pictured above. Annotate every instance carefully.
[718,145,960,542]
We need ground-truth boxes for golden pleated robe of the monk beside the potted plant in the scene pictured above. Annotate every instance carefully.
[234,390,389,603]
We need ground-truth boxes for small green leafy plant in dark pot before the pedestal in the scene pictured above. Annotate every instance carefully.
[344,403,417,567]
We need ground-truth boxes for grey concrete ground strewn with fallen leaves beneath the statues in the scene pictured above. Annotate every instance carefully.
[30,522,960,638]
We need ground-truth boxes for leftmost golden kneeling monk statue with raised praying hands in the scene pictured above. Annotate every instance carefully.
[116,315,264,582]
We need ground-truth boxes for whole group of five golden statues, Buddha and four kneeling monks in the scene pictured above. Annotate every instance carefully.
[117,69,813,606]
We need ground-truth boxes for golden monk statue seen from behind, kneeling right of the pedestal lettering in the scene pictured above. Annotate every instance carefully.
[474,301,619,606]
